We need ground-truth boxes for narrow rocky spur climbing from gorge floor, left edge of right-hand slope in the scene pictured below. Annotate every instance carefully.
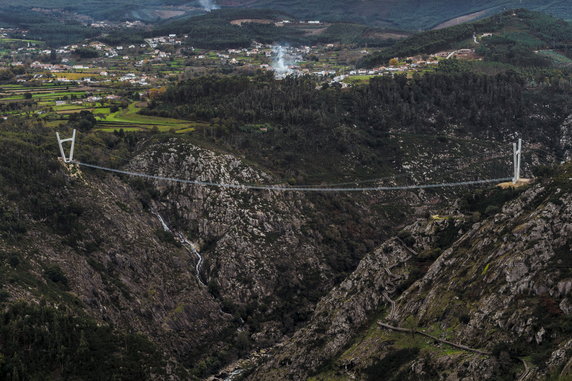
[252,239,412,380]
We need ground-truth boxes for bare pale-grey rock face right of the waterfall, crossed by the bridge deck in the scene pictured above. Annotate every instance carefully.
[130,141,340,332]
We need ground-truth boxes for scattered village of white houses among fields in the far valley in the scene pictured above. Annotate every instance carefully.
[0,26,487,91]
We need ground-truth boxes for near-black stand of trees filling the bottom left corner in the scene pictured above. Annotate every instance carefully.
[0,302,164,380]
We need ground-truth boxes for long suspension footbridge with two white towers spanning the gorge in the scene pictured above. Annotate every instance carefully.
[56,130,522,193]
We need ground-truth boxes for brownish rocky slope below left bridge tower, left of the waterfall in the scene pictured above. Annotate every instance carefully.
[64,171,230,360]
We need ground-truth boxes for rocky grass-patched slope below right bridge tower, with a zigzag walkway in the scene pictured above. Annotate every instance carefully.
[250,165,572,380]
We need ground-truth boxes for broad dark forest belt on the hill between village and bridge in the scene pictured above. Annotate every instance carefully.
[142,72,570,181]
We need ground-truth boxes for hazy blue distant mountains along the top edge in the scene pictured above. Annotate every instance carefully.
[0,0,572,30]
